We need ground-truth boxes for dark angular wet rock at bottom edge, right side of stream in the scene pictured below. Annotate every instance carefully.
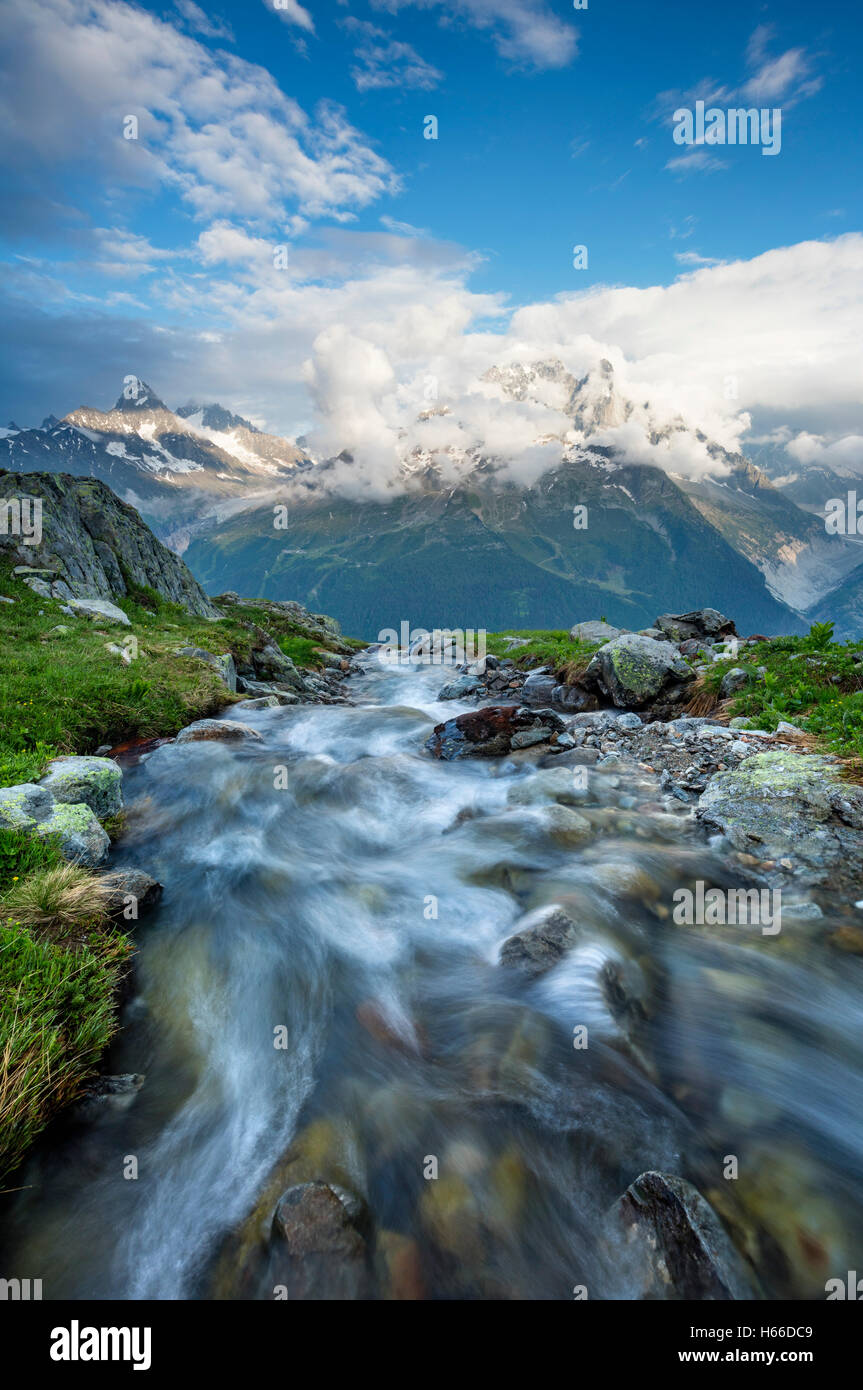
[614,1173,756,1300]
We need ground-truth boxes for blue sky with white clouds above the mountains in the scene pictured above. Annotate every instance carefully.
[0,0,863,472]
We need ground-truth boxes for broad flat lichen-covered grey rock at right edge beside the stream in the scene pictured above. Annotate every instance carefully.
[696,751,863,888]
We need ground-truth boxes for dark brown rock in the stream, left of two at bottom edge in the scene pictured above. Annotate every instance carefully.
[270,1182,368,1298]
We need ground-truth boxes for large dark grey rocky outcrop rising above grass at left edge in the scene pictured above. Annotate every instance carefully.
[0,473,218,617]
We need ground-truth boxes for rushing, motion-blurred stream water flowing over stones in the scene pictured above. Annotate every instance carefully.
[0,663,863,1298]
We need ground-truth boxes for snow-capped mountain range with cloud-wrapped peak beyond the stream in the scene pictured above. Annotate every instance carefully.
[0,360,863,631]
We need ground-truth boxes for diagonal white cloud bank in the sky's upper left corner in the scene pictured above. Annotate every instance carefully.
[0,0,397,221]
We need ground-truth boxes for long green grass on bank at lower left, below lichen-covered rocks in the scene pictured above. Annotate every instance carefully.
[0,920,131,1179]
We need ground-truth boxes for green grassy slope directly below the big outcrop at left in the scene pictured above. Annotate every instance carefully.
[0,569,354,787]
